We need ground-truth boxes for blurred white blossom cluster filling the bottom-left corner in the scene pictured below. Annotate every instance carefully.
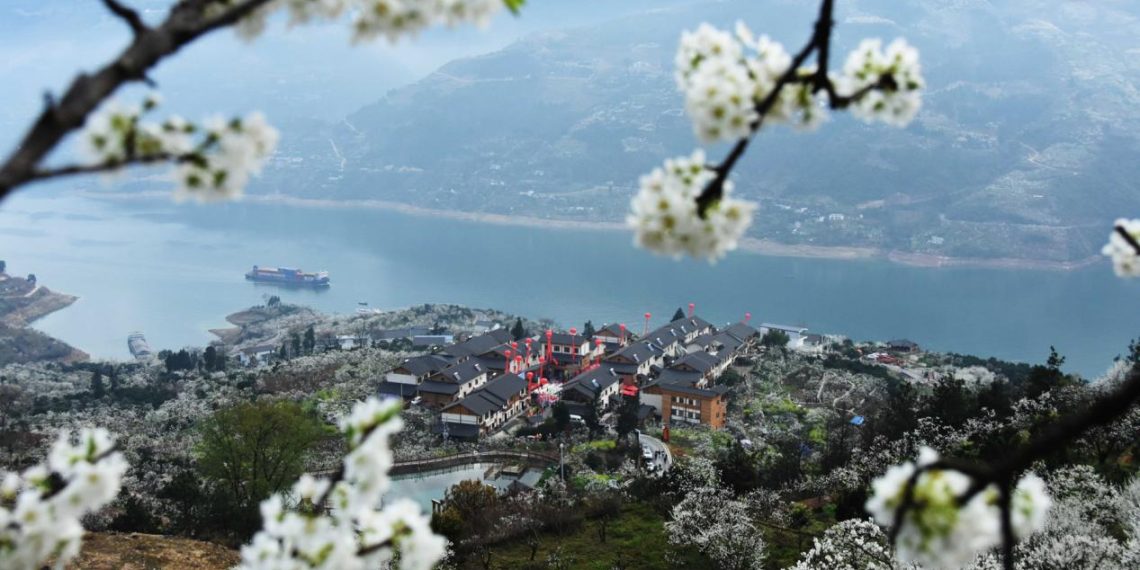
[0,429,128,570]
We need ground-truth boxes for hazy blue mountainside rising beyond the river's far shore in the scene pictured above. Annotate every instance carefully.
[249,0,1140,261]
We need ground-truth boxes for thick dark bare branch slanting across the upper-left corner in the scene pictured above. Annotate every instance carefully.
[0,0,269,200]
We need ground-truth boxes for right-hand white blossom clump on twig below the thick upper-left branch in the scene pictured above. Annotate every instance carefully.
[174,113,278,202]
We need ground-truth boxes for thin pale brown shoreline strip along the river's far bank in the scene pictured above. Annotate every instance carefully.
[88,192,1102,271]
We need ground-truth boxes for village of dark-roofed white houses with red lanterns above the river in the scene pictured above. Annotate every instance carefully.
[364,304,848,440]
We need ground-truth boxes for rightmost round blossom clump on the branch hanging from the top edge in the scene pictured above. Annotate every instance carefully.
[837,39,926,127]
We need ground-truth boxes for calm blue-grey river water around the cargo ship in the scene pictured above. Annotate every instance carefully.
[0,189,1140,375]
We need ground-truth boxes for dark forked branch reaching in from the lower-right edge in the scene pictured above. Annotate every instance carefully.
[888,365,1140,570]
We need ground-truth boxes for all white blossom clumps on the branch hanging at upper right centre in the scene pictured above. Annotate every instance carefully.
[627,22,925,260]
